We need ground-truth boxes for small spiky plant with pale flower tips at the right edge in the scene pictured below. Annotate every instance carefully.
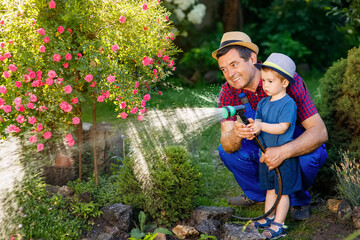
[332,152,360,206]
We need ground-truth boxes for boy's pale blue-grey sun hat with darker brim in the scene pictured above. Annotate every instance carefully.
[262,53,296,85]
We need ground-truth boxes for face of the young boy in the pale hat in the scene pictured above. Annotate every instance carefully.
[261,70,289,96]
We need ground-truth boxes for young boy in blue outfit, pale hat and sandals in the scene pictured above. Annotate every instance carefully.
[248,53,302,239]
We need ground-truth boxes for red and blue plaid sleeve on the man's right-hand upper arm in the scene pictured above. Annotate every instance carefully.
[287,73,318,122]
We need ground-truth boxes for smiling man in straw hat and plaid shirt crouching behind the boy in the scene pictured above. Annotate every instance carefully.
[212,32,328,220]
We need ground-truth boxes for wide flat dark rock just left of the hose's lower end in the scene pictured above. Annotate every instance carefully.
[192,206,235,224]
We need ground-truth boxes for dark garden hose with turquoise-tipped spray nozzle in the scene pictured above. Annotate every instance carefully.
[221,105,282,221]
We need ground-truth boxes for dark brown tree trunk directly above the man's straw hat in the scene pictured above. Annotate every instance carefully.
[223,0,243,32]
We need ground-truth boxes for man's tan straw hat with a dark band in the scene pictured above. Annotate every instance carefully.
[211,32,259,59]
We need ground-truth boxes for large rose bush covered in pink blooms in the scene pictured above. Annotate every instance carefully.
[0,0,178,151]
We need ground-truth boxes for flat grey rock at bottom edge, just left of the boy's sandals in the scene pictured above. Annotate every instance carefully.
[222,223,263,240]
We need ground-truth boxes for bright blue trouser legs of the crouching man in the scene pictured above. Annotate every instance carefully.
[219,139,327,206]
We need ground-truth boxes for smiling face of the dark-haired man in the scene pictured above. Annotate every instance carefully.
[218,49,255,89]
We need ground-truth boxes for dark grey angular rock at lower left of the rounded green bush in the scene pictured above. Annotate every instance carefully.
[100,203,133,232]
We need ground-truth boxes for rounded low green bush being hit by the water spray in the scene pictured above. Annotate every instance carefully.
[114,146,200,224]
